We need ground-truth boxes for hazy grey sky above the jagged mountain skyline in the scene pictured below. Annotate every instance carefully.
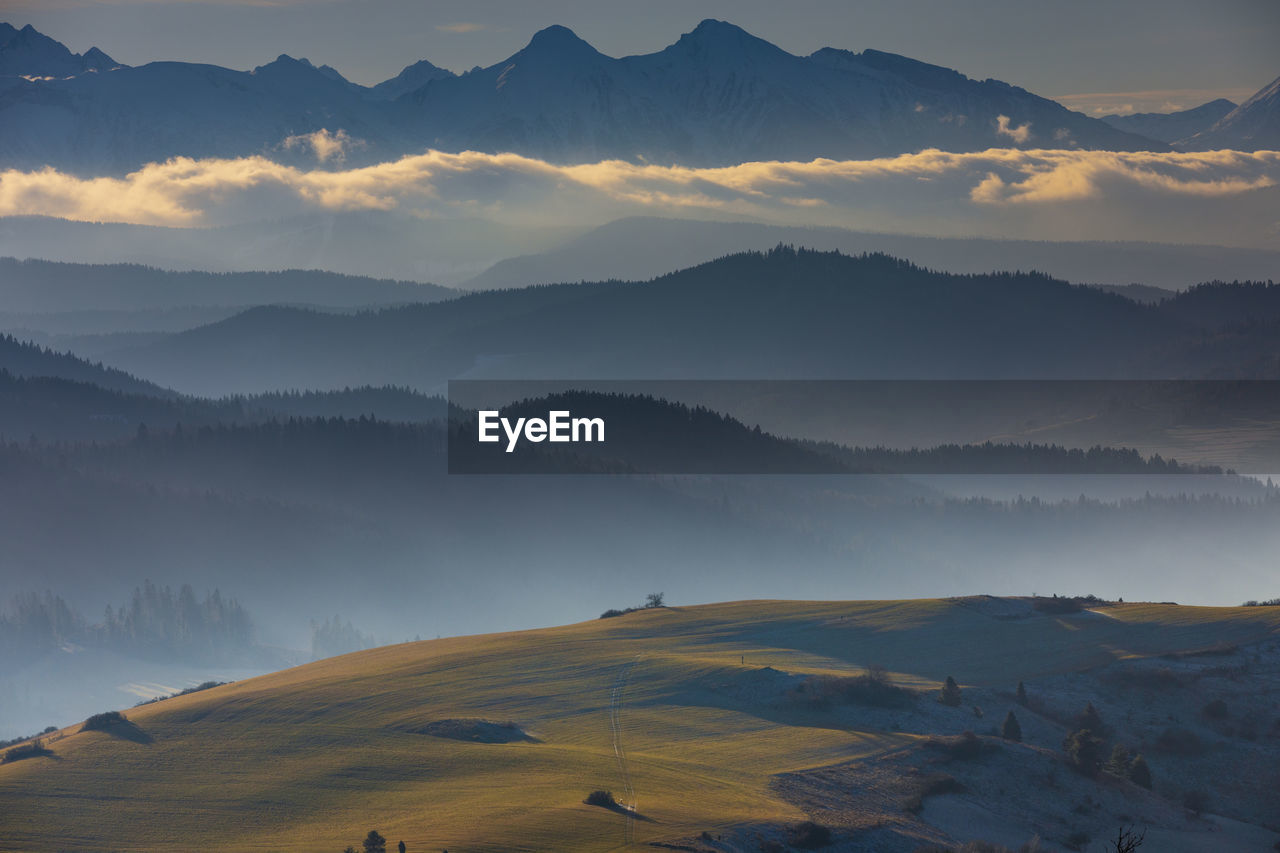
[0,0,1280,111]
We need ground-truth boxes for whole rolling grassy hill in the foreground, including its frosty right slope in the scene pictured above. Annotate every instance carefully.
[0,597,1280,852]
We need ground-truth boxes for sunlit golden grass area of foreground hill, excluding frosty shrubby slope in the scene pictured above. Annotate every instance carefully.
[0,598,1280,853]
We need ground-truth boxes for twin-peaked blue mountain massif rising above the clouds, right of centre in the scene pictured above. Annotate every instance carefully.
[406,20,1161,164]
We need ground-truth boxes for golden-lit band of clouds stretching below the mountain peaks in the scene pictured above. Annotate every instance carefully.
[0,144,1280,247]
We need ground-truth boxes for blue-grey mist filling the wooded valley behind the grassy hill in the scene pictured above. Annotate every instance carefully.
[0,419,1280,736]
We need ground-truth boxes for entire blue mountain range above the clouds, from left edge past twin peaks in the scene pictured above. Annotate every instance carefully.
[0,20,1167,173]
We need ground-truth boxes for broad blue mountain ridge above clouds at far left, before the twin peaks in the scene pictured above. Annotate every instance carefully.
[0,50,407,174]
